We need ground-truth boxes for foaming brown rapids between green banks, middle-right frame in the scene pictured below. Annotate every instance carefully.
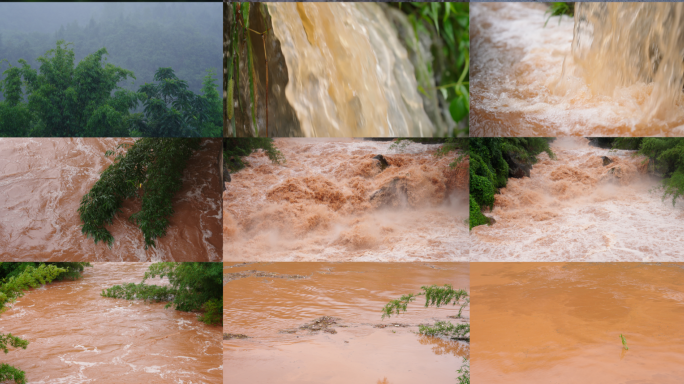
[470,138,684,261]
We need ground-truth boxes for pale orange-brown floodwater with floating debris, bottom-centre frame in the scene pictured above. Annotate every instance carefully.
[223,263,470,384]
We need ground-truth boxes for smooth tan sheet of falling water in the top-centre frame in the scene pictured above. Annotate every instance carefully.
[268,3,437,137]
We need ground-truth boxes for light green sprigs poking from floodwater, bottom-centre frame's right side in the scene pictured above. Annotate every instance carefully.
[382,284,470,384]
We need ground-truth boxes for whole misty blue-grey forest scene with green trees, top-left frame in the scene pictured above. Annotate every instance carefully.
[0,3,223,137]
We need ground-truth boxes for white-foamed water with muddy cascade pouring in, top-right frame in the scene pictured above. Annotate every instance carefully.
[470,3,684,136]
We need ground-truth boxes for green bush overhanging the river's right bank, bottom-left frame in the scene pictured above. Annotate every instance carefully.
[101,262,223,324]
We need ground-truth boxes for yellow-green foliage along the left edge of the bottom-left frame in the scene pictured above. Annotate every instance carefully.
[0,263,67,384]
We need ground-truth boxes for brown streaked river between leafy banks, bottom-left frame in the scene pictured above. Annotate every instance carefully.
[0,262,223,384]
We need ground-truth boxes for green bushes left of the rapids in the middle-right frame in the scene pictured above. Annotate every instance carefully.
[469,138,555,229]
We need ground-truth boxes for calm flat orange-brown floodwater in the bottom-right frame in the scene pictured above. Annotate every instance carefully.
[471,263,684,384]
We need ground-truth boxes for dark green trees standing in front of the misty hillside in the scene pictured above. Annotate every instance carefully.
[0,40,222,137]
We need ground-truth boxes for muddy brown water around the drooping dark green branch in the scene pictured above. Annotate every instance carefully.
[0,138,222,261]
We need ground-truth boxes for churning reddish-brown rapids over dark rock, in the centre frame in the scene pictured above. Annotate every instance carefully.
[223,139,468,261]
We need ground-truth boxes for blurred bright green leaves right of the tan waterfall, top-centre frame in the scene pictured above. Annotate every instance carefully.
[392,2,470,134]
